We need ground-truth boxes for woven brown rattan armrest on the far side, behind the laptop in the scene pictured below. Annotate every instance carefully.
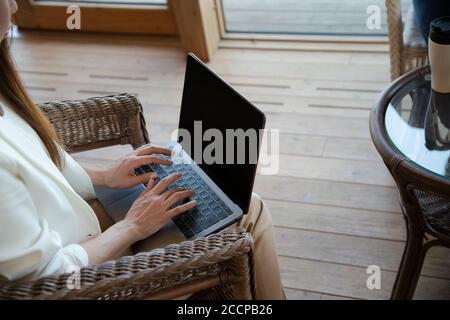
[39,93,149,152]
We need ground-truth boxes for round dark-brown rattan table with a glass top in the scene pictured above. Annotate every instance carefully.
[370,67,450,299]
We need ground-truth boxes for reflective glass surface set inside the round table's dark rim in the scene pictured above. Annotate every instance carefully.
[384,69,450,179]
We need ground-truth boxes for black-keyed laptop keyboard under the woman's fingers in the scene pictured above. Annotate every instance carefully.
[136,155,232,239]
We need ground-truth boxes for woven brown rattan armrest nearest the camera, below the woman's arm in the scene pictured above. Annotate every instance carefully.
[0,228,253,299]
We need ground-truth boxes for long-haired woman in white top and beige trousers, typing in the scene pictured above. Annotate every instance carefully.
[0,0,284,299]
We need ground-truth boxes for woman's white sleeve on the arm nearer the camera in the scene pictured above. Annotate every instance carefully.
[0,163,88,280]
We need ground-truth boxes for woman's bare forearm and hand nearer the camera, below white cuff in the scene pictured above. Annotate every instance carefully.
[81,173,197,264]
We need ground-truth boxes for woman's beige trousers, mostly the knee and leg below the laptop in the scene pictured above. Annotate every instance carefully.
[91,193,286,300]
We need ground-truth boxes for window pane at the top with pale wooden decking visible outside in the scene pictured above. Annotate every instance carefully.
[221,0,411,36]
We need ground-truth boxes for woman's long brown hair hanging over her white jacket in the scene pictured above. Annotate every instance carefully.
[0,37,62,169]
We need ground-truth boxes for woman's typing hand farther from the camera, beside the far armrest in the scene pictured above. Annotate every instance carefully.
[84,145,172,188]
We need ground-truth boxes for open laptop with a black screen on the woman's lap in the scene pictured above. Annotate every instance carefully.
[95,54,266,249]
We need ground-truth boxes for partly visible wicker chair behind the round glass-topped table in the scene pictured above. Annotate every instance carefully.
[386,0,428,80]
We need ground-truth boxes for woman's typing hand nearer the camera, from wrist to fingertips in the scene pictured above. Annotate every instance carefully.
[123,173,197,241]
